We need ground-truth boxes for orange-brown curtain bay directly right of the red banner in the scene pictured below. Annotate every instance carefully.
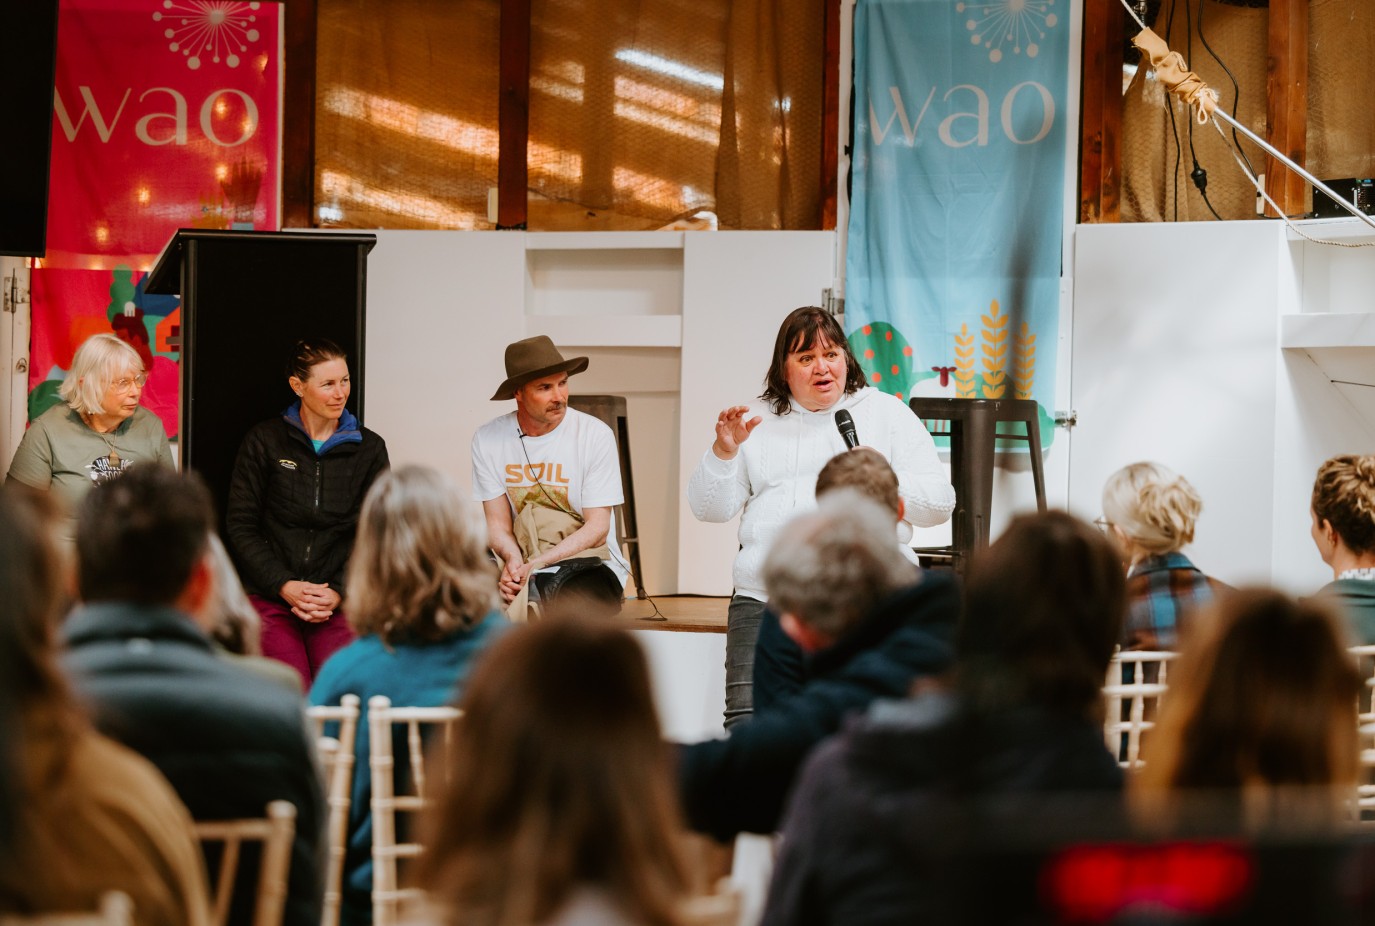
[315,0,501,228]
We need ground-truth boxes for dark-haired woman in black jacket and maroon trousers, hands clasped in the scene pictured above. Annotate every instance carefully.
[226,338,388,689]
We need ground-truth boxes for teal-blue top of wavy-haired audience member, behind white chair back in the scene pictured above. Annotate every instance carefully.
[311,611,510,923]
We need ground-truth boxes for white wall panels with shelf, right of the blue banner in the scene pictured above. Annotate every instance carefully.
[1070,222,1375,593]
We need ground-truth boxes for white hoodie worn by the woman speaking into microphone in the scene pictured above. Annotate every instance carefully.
[688,387,954,601]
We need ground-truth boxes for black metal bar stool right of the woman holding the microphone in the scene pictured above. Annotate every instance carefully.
[908,396,1045,574]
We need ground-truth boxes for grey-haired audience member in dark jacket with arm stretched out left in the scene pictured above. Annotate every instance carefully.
[679,490,957,839]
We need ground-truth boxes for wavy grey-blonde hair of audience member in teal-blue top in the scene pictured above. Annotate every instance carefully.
[347,466,496,644]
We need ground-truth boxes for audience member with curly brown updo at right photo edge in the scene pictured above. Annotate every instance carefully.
[1312,455,1375,645]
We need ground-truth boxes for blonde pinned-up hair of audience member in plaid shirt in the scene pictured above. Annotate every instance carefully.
[1103,462,1203,556]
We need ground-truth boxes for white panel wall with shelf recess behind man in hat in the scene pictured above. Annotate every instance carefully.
[354,231,836,594]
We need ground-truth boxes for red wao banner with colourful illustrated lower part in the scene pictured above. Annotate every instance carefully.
[29,0,282,438]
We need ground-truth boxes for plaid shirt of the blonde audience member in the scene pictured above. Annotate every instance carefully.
[1122,553,1227,649]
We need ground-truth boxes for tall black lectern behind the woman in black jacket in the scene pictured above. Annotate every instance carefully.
[147,228,377,524]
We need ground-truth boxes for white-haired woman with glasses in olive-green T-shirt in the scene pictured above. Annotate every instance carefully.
[8,334,172,535]
